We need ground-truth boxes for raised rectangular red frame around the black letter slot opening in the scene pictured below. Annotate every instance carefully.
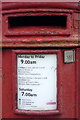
[3,10,72,36]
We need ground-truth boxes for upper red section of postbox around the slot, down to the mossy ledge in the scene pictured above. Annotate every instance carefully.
[2,3,79,47]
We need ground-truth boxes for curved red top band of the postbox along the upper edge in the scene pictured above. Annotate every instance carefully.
[3,0,79,10]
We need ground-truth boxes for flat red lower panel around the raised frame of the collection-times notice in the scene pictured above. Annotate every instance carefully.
[3,49,76,118]
